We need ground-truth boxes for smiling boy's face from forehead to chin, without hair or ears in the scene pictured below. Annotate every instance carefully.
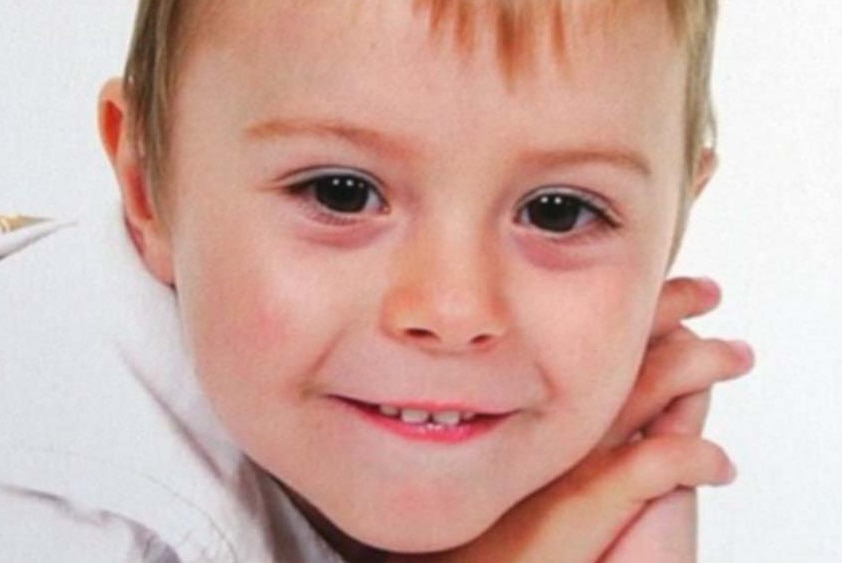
[154,0,685,550]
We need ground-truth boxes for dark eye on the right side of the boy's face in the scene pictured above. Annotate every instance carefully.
[517,188,617,234]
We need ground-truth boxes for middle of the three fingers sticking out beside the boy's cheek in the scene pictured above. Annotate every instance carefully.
[602,337,754,448]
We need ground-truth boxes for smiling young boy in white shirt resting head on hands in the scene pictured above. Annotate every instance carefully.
[0,0,751,562]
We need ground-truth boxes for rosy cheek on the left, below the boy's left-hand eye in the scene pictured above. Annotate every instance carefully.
[171,216,378,415]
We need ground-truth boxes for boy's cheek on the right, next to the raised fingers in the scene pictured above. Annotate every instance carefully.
[527,266,660,432]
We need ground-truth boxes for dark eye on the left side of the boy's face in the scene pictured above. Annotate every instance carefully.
[287,171,388,216]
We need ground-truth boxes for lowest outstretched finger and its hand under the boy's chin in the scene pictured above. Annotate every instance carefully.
[403,436,734,563]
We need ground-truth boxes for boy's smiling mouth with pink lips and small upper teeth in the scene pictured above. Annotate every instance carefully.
[334,397,514,444]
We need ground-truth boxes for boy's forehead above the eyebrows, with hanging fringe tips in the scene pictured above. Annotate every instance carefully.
[177,0,685,184]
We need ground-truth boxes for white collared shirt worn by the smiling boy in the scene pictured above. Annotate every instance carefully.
[0,209,340,563]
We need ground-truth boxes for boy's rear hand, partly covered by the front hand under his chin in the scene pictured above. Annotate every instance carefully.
[600,280,753,563]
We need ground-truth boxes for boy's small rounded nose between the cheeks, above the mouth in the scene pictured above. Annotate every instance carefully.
[382,229,509,353]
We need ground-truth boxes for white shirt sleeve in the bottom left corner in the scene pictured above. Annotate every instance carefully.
[0,485,179,563]
